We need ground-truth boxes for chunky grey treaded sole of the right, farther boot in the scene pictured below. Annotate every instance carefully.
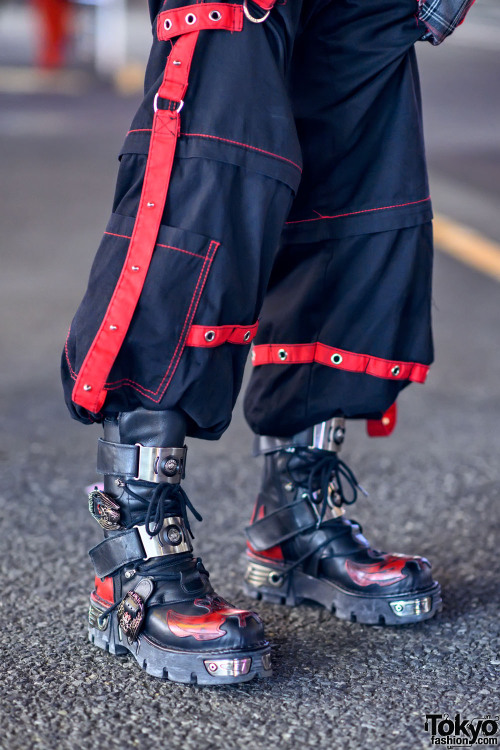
[244,561,442,625]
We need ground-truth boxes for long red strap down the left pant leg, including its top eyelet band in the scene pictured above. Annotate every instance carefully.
[72,3,243,413]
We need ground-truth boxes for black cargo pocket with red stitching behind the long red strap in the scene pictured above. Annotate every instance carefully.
[66,214,219,403]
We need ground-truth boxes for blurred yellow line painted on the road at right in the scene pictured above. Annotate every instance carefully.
[434,215,500,281]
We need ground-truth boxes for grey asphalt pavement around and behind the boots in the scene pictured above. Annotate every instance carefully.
[0,11,500,750]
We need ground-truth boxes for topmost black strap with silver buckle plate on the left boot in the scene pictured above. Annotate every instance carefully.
[97,438,187,484]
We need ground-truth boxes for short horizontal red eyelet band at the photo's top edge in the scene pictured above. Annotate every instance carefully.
[156,3,243,42]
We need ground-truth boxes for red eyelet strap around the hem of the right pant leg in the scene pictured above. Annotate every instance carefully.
[252,343,429,383]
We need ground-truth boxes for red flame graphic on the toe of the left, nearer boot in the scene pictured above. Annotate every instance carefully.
[167,596,255,641]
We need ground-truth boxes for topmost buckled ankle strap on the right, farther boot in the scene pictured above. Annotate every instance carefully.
[254,417,345,456]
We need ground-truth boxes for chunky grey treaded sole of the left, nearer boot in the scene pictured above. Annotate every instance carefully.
[89,599,272,685]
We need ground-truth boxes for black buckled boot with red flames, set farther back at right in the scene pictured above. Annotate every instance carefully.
[245,419,441,625]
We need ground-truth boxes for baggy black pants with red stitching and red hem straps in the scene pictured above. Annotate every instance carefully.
[62,0,433,439]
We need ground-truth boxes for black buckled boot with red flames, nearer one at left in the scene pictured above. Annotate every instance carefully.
[89,409,271,685]
